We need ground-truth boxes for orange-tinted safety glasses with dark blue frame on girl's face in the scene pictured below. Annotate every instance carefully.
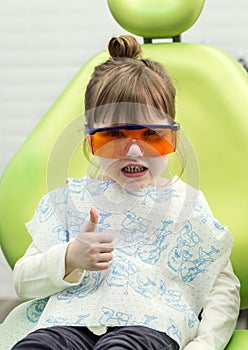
[86,123,180,158]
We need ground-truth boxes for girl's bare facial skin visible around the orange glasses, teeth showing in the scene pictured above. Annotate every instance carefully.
[94,119,169,189]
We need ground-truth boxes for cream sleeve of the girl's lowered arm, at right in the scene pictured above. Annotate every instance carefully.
[184,260,240,350]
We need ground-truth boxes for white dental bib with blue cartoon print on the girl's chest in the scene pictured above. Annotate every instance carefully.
[1,178,232,347]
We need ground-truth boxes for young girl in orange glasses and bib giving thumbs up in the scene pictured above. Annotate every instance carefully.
[0,36,239,350]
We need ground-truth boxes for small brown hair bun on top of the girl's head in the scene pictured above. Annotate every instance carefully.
[108,35,142,58]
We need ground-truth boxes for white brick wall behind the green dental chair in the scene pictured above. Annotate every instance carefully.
[0,0,248,297]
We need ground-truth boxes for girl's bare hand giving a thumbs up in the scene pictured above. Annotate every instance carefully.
[65,209,114,276]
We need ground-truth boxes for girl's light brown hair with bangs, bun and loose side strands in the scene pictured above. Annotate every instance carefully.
[84,35,184,177]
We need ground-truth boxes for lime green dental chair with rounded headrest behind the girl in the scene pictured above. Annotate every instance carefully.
[0,0,248,350]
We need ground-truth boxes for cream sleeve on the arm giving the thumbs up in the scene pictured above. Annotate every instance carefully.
[14,242,84,299]
